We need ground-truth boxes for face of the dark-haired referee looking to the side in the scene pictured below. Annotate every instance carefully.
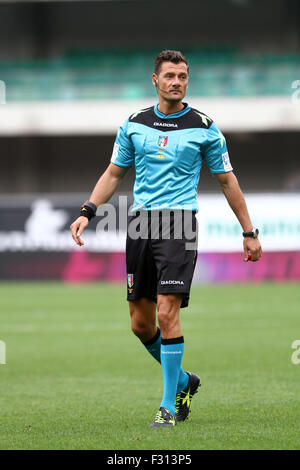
[152,62,189,101]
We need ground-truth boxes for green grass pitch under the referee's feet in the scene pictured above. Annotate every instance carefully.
[0,283,300,450]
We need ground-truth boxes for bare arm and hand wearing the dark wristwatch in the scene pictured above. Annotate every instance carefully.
[216,172,262,261]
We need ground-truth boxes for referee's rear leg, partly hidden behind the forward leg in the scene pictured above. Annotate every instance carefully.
[129,298,189,393]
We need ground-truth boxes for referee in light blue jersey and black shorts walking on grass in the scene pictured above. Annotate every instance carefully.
[70,50,262,427]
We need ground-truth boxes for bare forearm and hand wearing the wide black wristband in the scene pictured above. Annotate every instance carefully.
[70,163,129,246]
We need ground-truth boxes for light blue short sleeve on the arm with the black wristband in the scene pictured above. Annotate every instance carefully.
[110,119,134,167]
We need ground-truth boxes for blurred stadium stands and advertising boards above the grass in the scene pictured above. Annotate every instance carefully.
[0,0,300,283]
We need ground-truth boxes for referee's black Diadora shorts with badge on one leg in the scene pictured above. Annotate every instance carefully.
[126,210,198,308]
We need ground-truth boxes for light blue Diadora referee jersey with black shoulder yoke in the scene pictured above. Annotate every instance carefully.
[111,104,232,212]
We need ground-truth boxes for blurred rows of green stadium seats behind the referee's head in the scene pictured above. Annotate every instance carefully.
[0,48,300,102]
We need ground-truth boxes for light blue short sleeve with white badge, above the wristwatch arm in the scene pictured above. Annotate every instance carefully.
[202,123,233,173]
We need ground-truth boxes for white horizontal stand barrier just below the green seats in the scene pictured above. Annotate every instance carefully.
[0,96,300,135]
